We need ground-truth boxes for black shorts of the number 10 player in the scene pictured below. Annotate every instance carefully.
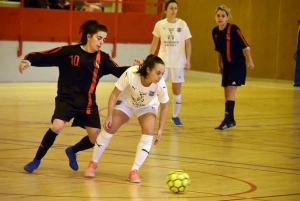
[51,98,101,129]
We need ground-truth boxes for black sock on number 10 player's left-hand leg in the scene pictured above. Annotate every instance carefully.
[34,129,57,160]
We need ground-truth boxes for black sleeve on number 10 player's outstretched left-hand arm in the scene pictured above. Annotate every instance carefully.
[24,47,62,67]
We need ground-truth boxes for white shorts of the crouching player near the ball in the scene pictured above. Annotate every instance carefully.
[115,100,158,118]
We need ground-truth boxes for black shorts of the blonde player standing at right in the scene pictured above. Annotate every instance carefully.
[222,62,247,87]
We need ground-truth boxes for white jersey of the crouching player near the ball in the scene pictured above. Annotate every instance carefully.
[115,66,169,108]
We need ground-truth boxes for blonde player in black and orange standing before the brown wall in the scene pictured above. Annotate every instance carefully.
[212,6,254,130]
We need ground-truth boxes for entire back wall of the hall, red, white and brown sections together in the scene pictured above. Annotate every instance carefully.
[0,0,300,82]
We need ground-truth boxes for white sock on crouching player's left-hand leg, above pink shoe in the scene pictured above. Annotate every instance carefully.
[92,129,113,163]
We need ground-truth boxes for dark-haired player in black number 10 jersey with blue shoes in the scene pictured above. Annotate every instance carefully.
[19,20,129,173]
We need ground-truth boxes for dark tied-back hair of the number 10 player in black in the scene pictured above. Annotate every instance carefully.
[79,20,107,45]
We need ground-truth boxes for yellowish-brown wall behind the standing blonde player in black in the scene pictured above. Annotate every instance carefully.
[178,0,300,80]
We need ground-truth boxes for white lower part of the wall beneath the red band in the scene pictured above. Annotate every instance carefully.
[0,41,150,82]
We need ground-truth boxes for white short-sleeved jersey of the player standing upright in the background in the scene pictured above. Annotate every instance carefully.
[152,19,192,68]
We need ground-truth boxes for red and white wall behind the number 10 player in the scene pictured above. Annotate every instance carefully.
[0,0,160,82]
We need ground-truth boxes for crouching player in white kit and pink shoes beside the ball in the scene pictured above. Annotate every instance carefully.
[84,55,169,183]
